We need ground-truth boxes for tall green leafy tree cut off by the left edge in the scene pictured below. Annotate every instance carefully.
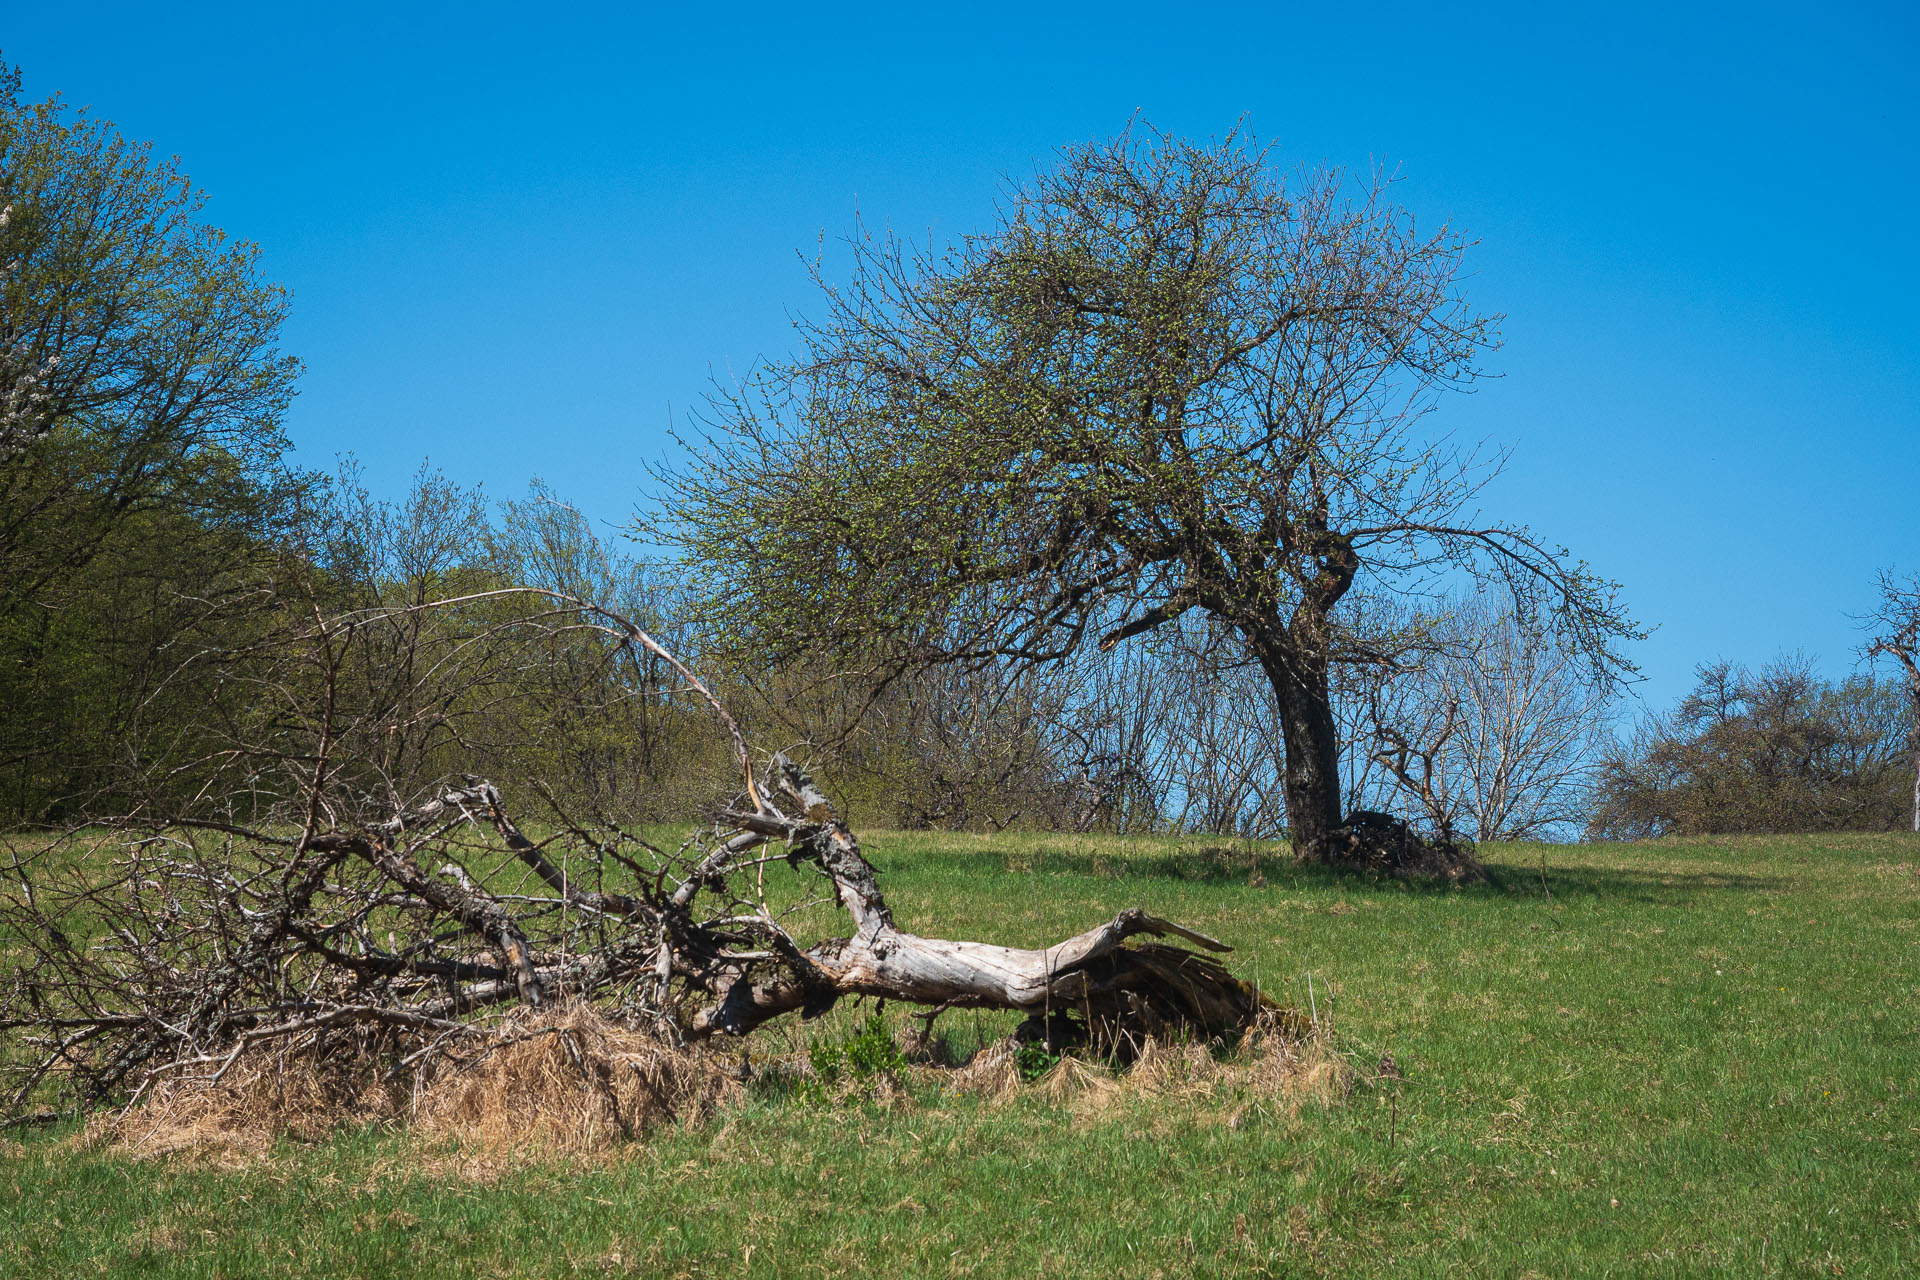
[0,65,311,818]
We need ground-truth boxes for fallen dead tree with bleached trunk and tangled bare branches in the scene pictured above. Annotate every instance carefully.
[0,591,1271,1119]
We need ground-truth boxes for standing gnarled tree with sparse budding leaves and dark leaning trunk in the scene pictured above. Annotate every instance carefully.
[653,129,1632,858]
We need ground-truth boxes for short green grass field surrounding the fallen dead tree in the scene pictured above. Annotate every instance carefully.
[0,835,1920,1278]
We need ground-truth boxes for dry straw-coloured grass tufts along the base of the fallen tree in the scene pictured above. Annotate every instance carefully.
[77,1004,1354,1176]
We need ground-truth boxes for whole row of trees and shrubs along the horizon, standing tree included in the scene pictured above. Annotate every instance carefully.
[0,71,1920,860]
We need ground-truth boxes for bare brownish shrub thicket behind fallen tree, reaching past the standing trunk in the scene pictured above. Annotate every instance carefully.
[3,435,1620,839]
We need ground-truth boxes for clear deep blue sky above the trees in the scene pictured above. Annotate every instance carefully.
[0,2,1920,704]
